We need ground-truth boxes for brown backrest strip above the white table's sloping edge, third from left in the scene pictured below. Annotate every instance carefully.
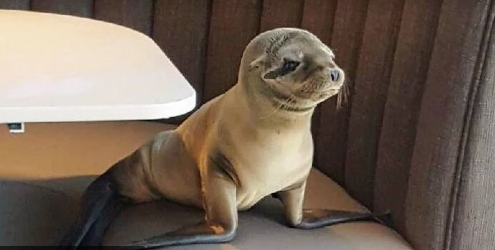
[94,0,153,35]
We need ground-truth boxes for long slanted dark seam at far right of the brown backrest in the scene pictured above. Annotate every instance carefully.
[444,1,494,250]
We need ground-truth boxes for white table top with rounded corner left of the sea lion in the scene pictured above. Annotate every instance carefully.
[0,10,196,123]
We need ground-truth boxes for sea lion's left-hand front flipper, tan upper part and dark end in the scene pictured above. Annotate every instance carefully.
[126,163,237,249]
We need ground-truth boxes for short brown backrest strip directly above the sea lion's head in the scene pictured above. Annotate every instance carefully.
[260,0,304,31]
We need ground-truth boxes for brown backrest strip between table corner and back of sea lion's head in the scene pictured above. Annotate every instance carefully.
[203,0,261,101]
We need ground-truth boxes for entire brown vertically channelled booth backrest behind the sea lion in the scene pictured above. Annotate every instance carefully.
[0,0,495,249]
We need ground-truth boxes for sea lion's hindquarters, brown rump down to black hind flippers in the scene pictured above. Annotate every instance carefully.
[59,140,162,249]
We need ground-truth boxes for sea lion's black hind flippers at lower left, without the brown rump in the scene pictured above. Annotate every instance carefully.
[59,171,128,249]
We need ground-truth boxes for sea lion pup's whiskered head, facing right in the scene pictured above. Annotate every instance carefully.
[239,28,347,113]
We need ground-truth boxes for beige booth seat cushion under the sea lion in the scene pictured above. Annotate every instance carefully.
[0,122,411,250]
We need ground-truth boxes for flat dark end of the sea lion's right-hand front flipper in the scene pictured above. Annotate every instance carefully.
[295,209,391,229]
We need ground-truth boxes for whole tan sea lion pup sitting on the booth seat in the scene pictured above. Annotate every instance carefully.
[60,28,388,248]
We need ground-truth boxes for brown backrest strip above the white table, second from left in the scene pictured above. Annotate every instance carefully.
[31,0,93,17]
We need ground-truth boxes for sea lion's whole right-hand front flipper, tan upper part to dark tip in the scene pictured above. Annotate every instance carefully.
[276,182,391,229]
